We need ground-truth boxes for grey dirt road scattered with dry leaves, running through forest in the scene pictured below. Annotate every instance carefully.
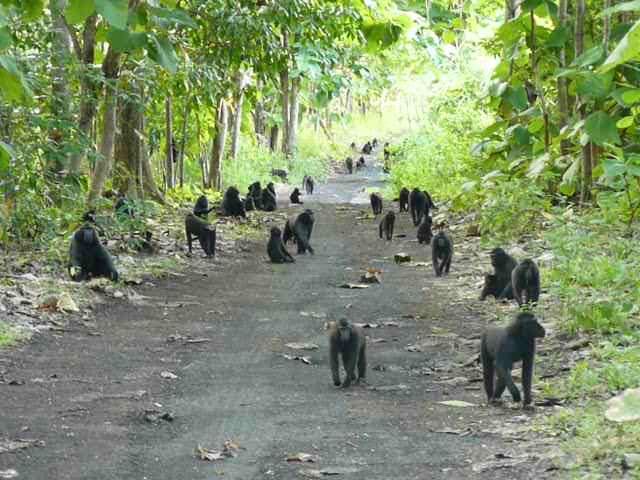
[0,159,544,480]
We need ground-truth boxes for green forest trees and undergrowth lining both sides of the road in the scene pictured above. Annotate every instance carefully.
[0,0,640,478]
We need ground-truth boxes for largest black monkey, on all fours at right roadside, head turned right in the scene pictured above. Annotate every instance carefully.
[480,312,546,407]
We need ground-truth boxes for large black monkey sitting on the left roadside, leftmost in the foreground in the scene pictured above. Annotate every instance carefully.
[67,224,119,282]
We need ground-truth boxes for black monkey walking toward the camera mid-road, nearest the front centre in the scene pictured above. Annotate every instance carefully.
[329,318,367,388]
